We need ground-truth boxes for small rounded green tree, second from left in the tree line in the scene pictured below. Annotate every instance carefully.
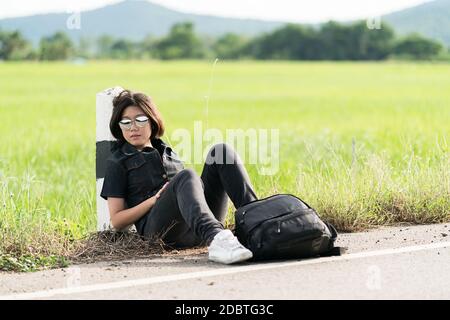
[39,32,75,60]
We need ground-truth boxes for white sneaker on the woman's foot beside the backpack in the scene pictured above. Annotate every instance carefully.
[208,229,253,264]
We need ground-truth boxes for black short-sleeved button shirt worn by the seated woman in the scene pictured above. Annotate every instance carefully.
[100,138,184,231]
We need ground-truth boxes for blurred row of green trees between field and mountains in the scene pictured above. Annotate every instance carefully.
[0,21,449,60]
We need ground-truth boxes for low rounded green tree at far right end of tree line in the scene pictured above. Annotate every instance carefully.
[394,34,442,59]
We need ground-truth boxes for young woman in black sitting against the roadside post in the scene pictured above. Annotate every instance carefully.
[101,90,257,264]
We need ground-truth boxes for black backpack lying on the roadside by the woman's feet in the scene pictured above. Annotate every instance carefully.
[235,194,340,260]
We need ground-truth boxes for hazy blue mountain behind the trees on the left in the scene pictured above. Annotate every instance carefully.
[0,0,283,44]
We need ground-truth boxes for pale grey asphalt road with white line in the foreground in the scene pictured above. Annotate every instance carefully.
[0,223,450,300]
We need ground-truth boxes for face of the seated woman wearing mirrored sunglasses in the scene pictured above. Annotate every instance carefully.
[121,106,152,150]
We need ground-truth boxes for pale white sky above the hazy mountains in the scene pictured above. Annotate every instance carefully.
[0,0,429,23]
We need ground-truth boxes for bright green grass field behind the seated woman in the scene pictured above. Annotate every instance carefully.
[0,61,450,269]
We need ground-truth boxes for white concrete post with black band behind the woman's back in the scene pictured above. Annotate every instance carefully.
[95,87,123,231]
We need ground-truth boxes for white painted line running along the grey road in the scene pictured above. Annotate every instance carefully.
[0,242,450,300]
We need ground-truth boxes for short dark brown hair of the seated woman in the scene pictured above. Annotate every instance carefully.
[109,90,165,143]
